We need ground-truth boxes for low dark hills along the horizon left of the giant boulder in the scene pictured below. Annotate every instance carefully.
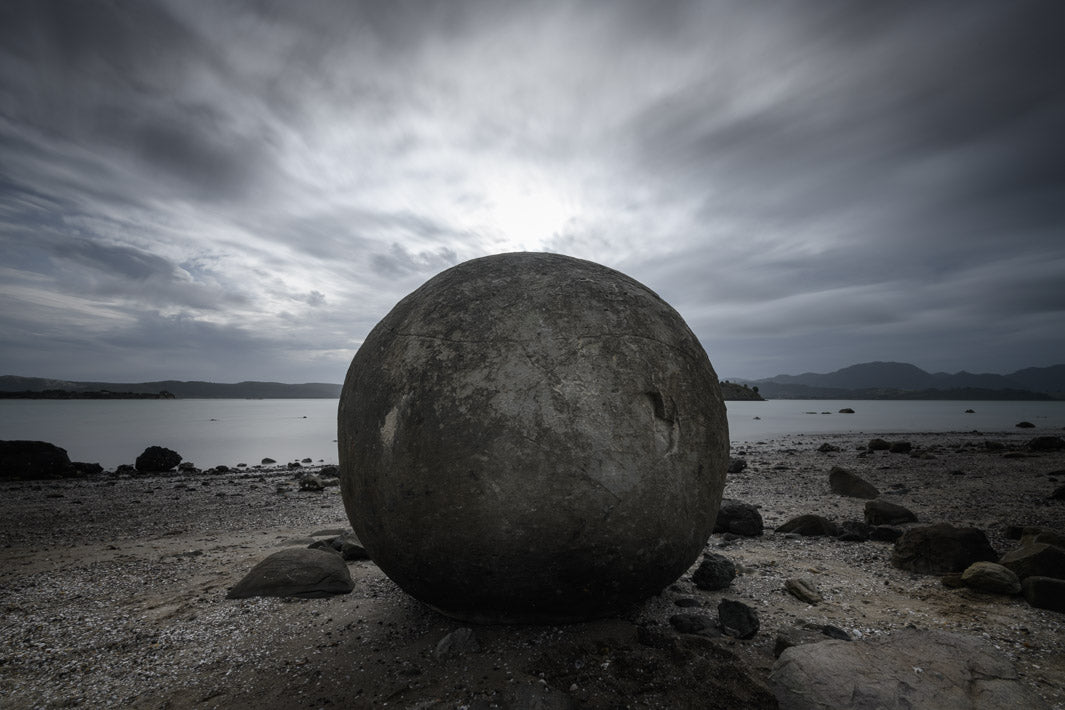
[0,375,341,399]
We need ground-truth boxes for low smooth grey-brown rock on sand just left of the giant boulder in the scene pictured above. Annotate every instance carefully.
[226,547,355,599]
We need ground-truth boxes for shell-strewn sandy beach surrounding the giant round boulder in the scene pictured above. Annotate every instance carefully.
[0,429,1065,710]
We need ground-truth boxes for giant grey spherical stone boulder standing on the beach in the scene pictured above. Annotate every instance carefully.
[338,253,728,623]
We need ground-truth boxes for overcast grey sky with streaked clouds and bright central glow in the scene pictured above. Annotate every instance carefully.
[0,0,1065,382]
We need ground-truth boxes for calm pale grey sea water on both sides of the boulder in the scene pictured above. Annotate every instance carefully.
[0,399,1065,468]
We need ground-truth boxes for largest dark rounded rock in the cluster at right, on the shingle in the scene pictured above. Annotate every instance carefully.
[891,523,998,575]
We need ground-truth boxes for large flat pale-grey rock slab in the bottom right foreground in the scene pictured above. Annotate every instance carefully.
[770,629,1046,710]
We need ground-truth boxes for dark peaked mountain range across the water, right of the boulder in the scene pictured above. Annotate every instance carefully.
[746,362,1065,399]
